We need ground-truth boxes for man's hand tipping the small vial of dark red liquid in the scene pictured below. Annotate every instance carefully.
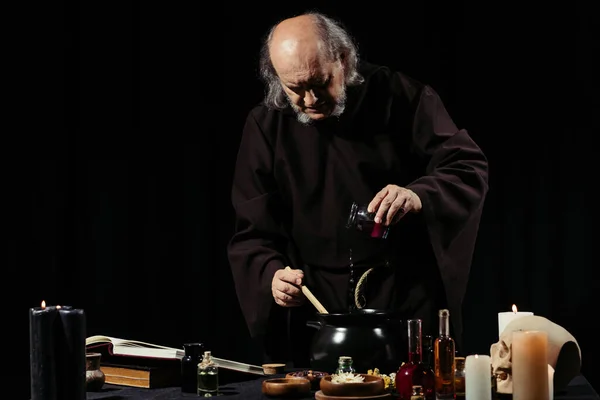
[367,185,423,225]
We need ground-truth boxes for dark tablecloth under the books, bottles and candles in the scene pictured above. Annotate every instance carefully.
[87,376,600,400]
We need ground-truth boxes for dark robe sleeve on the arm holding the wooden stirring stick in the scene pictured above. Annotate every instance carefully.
[228,113,289,338]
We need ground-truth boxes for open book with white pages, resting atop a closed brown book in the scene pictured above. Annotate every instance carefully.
[85,335,264,375]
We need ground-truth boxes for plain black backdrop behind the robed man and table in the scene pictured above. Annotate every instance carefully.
[11,1,600,396]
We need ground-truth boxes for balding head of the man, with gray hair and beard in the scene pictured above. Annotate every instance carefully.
[260,13,363,122]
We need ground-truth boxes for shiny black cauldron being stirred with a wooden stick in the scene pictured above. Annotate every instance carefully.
[308,309,408,374]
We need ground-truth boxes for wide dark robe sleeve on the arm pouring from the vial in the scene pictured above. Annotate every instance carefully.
[407,86,488,332]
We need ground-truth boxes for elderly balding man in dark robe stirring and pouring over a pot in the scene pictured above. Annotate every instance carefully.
[228,13,488,364]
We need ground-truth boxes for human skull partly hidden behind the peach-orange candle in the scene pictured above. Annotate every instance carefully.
[490,315,581,394]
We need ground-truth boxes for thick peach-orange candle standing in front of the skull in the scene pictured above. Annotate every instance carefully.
[512,331,550,400]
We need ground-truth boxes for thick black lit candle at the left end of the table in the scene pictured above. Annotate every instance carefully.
[29,303,86,400]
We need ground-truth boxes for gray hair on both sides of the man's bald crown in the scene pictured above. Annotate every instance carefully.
[259,12,364,109]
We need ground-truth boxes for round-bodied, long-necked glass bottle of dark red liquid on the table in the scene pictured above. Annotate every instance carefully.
[396,319,435,400]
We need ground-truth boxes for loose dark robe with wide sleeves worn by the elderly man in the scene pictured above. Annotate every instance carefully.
[228,63,488,361]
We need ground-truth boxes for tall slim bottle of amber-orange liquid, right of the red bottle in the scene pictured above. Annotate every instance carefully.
[433,309,456,400]
